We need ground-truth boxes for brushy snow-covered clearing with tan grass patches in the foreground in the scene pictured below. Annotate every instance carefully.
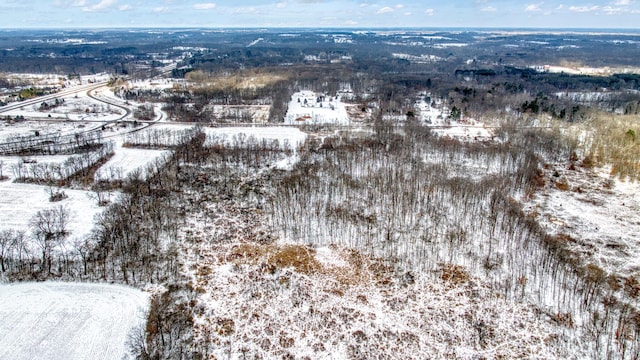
[182,231,566,359]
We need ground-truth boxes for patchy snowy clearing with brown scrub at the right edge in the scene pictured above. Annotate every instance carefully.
[526,165,640,277]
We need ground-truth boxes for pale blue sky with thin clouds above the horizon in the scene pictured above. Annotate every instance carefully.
[0,0,640,29]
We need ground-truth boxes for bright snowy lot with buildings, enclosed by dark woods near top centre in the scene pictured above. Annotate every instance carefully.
[284,91,350,125]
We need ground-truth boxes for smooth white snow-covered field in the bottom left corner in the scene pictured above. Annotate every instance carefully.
[0,282,148,360]
